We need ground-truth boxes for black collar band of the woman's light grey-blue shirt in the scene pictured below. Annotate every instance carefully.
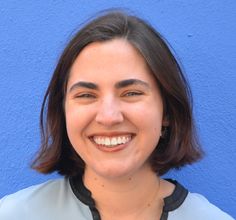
[69,176,188,220]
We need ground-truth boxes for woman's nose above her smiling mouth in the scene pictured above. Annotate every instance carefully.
[95,98,124,126]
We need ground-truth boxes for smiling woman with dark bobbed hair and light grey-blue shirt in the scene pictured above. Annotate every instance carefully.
[0,12,232,220]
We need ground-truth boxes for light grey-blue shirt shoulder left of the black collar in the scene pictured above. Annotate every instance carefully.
[0,178,91,220]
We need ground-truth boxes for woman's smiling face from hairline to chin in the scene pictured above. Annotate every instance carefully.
[65,39,163,178]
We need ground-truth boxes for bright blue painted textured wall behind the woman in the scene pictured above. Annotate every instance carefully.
[0,0,236,217]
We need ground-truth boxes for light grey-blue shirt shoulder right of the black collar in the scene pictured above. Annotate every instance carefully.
[169,192,233,220]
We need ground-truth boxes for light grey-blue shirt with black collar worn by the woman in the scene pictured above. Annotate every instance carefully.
[0,177,233,220]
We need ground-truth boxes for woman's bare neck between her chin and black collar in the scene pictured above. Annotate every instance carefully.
[84,167,163,220]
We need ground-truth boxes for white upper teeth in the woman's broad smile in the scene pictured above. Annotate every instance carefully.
[93,135,131,147]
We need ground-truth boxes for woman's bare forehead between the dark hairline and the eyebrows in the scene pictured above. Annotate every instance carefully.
[69,39,155,86]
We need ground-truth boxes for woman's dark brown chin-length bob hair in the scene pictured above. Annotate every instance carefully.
[32,11,202,177]
